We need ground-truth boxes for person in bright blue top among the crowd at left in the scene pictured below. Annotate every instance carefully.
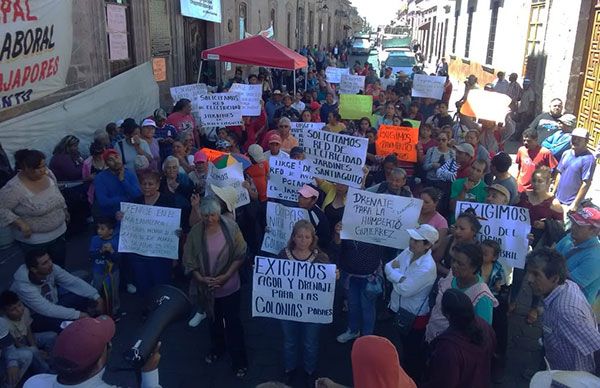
[92,149,142,217]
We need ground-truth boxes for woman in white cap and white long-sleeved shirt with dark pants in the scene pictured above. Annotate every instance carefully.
[385,224,439,381]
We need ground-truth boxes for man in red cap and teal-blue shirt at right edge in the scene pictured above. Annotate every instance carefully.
[556,207,600,305]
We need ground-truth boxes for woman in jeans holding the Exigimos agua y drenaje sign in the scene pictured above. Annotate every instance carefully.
[279,220,329,384]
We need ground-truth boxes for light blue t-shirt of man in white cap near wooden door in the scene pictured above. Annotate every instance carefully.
[555,149,596,205]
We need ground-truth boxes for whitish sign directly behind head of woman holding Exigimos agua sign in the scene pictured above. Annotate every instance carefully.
[261,202,309,255]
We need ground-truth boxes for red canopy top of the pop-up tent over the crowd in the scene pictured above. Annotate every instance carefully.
[202,35,308,70]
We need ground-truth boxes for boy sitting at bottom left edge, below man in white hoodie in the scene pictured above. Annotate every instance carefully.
[0,290,56,373]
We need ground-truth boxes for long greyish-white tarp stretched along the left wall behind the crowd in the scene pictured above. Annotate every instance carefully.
[0,62,160,162]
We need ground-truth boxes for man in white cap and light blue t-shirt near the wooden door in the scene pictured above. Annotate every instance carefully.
[554,128,596,217]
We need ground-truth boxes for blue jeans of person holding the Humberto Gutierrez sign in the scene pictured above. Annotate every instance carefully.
[344,274,377,335]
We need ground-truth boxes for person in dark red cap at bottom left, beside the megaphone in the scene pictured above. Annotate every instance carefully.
[23,315,160,388]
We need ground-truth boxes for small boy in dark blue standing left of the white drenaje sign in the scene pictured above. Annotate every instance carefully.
[90,217,121,316]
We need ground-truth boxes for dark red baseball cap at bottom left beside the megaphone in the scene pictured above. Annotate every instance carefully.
[52,315,115,372]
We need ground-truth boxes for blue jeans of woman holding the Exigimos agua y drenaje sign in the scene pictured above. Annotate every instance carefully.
[281,321,321,374]
